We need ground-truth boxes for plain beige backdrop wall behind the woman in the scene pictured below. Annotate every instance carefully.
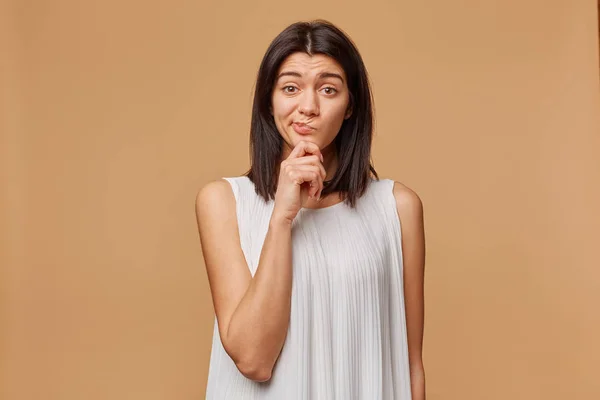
[0,0,600,400]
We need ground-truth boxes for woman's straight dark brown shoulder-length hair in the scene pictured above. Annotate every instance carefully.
[245,19,379,207]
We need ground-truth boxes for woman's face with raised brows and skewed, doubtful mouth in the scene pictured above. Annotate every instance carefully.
[271,53,351,158]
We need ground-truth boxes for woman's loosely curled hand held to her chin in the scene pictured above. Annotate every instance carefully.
[273,141,327,222]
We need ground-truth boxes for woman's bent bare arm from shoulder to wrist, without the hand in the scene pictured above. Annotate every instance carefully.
[196,180,292,382]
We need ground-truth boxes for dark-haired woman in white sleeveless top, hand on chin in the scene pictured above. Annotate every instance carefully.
[196,20,425,400]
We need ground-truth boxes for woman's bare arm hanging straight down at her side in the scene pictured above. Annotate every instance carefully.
[394,182,425,400]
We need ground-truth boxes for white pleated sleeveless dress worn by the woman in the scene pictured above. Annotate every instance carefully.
[206,176,411,400]
